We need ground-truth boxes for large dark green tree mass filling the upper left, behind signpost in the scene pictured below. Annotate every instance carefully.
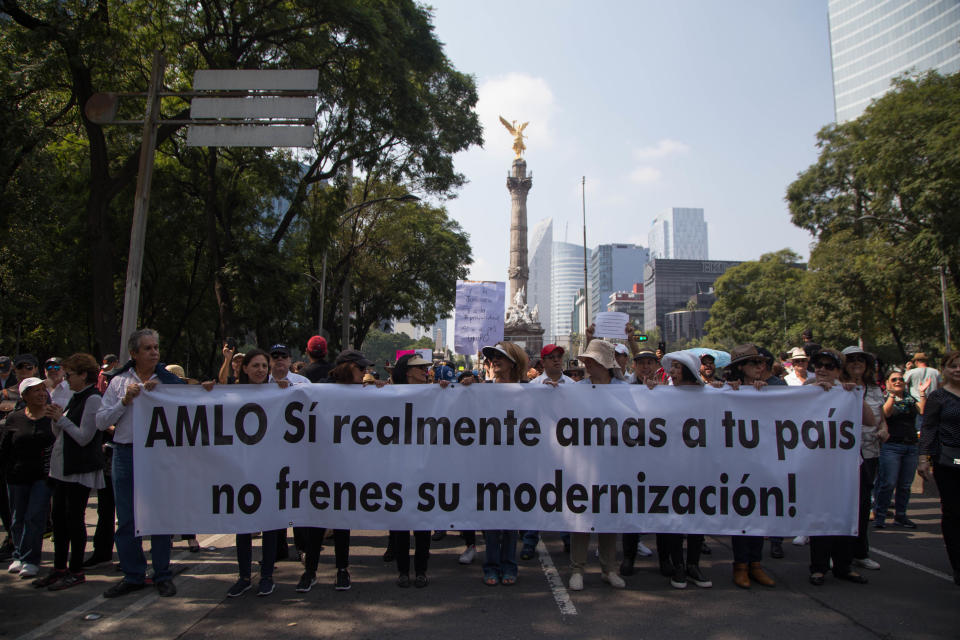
[0,0,482,376]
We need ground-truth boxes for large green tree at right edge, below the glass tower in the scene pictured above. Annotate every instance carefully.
[787,72,960,358]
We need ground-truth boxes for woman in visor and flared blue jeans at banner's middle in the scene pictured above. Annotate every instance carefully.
[482,342,528,587]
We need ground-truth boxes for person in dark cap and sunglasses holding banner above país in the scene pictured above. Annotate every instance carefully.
[807,348,877,587]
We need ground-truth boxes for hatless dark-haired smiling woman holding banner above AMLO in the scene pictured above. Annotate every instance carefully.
[227,349,290,598]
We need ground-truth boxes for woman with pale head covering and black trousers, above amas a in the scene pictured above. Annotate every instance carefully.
[647,351,713,589]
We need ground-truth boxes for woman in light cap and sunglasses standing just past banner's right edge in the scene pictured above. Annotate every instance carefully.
[840,346,888,570]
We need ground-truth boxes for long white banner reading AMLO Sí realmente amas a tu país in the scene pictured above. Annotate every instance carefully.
[134,384,861,536]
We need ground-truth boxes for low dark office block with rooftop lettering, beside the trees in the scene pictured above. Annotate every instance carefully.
[643,258,740,349]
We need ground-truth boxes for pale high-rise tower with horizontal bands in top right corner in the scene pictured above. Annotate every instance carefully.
[827,0,960,122]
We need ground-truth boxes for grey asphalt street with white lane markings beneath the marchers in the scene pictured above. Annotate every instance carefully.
[0,482,960,640]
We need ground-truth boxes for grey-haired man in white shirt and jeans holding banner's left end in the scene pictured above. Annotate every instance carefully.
[97,329,185,598]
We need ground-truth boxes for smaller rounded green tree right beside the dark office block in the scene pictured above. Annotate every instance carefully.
[703,249,807,352]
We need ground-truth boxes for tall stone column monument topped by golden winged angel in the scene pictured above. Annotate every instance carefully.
[500,116,543,363]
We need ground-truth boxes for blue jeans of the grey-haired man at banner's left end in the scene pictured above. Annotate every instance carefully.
[113,445,172,584]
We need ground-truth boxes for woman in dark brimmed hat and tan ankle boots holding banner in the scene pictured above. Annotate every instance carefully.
[726,344,776,589]
